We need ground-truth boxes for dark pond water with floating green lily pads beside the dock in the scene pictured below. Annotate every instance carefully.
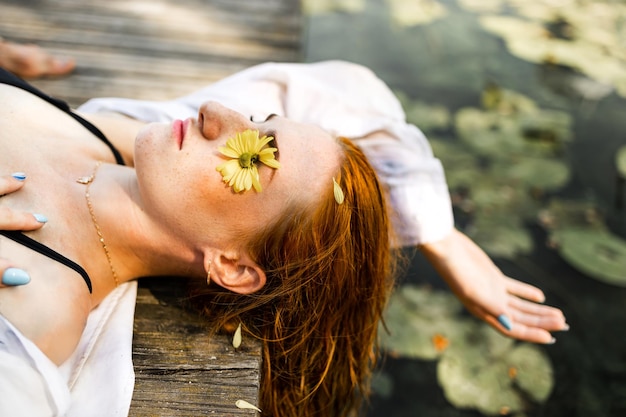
[305,0,626,417]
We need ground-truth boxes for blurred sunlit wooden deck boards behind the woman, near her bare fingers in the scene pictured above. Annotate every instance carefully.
[0,0,302,106]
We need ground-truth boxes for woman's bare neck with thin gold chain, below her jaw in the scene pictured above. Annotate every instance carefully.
[75,164,203,300]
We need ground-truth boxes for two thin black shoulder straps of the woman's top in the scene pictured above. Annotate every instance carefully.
[0,68,124,293]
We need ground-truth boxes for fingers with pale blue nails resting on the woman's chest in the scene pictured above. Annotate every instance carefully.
[0,173,47,287]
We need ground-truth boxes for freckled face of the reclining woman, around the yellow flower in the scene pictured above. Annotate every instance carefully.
[135,102,341,244]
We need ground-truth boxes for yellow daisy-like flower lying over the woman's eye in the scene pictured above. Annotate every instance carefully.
[215,129,280,193]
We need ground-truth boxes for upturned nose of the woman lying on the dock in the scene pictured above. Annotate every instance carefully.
[198,101,250,140]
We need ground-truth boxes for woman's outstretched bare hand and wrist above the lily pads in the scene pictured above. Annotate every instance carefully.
[419,229,569,343]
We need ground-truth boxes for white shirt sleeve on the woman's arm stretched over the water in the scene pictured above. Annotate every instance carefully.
[79,61,454,246]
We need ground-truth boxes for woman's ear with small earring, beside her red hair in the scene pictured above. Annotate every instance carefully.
[205,252,266,294]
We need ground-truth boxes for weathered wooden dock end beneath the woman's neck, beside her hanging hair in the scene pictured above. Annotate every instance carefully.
[130,280,261,417]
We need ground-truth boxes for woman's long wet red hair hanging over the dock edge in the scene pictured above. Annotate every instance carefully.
[190,138,393,417]
